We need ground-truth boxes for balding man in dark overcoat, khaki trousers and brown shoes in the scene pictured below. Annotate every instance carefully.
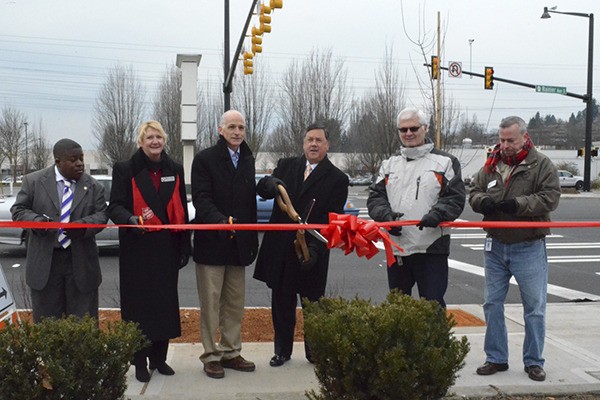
[192,110,258,378]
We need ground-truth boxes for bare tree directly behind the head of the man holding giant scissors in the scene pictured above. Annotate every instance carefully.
[272,50,350,155]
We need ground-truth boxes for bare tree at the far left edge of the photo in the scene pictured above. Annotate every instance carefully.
[0,106,27,181]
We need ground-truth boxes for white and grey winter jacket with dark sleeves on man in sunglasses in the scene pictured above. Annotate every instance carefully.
[367,142,465,256]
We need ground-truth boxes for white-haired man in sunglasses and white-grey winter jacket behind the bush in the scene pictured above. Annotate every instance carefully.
[367,108,466,307]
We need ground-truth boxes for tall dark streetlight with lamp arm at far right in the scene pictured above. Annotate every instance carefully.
[541,7,594,192]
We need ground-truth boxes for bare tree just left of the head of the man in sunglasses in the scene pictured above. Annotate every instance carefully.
[348,46,405,175]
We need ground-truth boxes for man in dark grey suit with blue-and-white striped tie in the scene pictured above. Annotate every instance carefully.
[10,139,108,322]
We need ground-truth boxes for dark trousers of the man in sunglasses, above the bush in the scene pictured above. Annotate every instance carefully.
[387,254,448,308]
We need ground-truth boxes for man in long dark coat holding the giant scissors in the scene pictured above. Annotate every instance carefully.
[254,124,348,367]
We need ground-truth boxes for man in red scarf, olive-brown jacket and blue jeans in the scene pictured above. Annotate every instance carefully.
[469,117,560,381]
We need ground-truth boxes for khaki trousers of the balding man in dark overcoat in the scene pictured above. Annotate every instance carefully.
[196,263,246,363]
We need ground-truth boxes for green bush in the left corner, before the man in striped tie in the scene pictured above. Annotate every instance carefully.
[0,317,146,400]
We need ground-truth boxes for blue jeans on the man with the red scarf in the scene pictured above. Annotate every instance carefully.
[483,239,548,367]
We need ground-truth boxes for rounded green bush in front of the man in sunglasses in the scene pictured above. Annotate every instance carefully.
[304,292,469,400]
